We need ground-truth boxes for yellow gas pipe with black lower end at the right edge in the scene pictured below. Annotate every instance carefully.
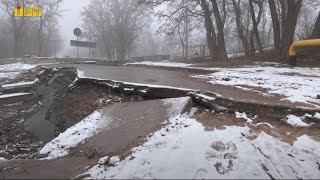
[289,39,320,65]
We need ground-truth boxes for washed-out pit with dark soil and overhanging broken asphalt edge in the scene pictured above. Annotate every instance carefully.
[0,67,317,159]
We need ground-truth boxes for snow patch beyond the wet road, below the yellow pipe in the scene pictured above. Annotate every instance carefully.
[192,66,320,103]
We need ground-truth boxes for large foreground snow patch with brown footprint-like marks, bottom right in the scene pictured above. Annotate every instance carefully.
[85,114,320,179]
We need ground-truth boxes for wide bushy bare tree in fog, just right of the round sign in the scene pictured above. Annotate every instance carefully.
[81,0,151,59]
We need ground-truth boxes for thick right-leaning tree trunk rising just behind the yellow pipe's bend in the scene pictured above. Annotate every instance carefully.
[282,0,302,57]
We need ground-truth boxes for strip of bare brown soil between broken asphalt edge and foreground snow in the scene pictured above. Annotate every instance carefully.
[195,108,320,145]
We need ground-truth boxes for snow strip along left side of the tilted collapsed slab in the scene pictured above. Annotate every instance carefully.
[40,110,112,159]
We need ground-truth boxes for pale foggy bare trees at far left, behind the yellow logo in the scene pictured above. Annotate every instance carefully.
[0,0,62,57]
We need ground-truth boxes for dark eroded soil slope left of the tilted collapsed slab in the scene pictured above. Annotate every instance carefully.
[0,67,143,159]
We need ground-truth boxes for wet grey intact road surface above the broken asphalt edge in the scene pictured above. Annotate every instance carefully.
[50,64,318,107]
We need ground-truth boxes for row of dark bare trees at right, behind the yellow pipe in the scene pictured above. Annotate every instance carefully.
[141,0,320,60]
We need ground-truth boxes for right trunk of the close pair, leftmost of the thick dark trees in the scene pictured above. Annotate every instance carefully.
[210,0,228,60]
